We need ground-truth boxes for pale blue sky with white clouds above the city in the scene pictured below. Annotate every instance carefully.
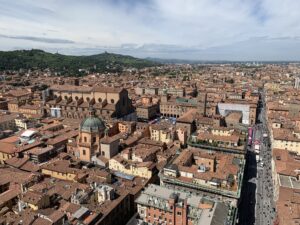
[0,0,300,60]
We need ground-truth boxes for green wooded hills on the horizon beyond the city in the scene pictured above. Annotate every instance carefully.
[0,49,159,75]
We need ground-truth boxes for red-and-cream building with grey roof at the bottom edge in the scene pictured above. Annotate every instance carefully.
[136,184,232,225]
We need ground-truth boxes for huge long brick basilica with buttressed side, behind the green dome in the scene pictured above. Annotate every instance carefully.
[45,85,134,119]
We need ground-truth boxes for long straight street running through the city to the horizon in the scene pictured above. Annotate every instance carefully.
[238,90,275,225]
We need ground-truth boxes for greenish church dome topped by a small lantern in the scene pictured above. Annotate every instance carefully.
[80,107,105,133]
